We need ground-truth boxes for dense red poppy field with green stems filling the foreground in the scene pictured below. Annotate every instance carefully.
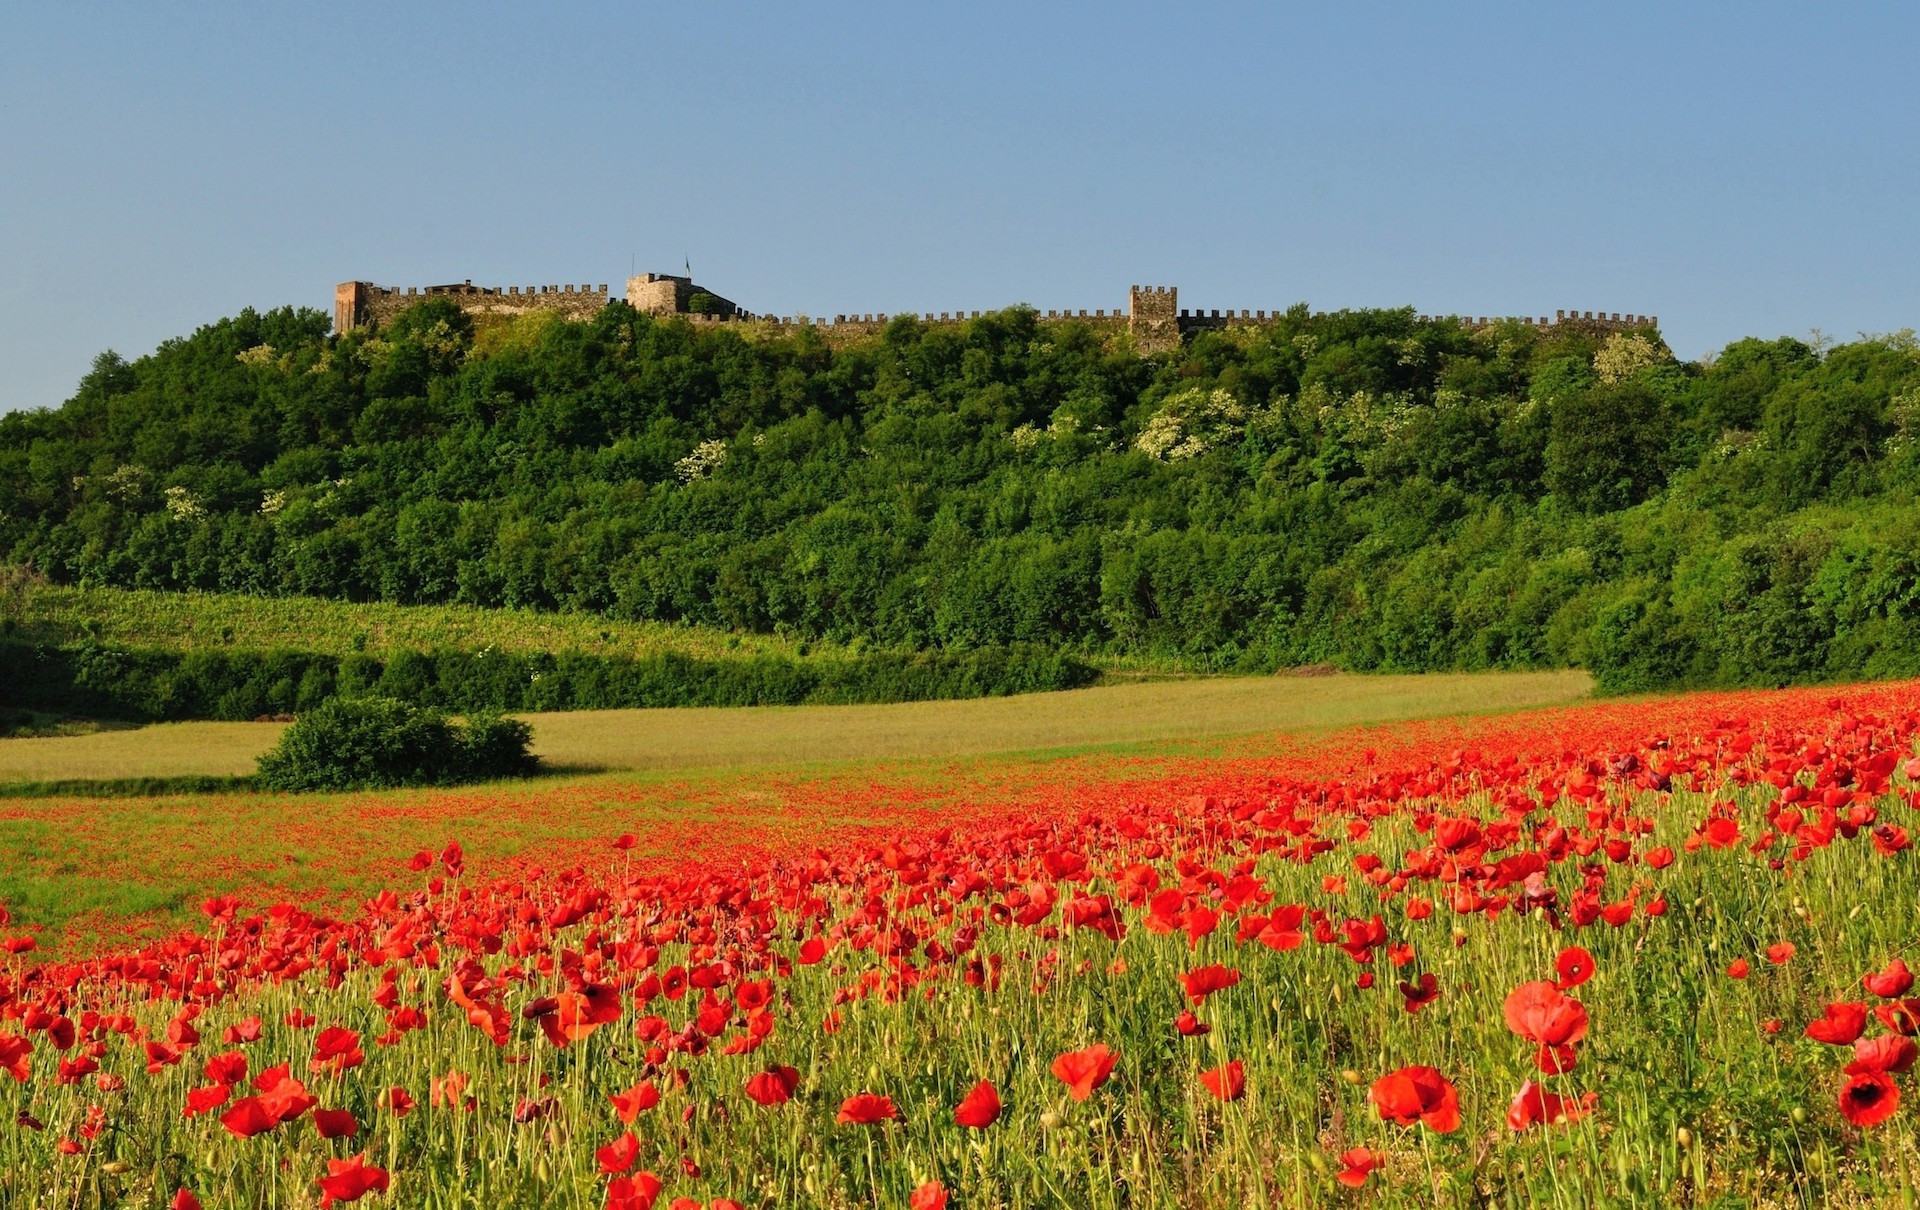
[0,684,1920,1210]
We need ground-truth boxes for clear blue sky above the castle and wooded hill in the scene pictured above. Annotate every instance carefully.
[0,0,1920,409]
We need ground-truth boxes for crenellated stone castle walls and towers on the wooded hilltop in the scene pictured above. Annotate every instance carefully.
[334,273,1661,353]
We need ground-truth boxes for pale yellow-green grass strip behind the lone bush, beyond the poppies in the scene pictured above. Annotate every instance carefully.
[0,672,1592,784]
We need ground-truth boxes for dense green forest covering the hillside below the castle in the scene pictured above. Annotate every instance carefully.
[0,302,1920,690]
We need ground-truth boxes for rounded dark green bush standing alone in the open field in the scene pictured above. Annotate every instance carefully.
[259,697,540,791]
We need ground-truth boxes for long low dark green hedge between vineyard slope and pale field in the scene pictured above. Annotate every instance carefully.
[0,641,1098,720]
